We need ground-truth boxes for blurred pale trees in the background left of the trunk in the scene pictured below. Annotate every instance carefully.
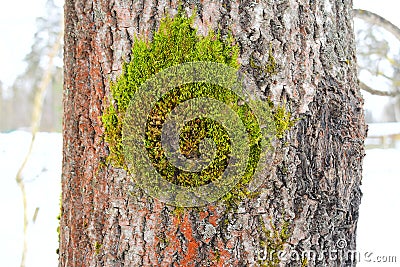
[0,0,63,131]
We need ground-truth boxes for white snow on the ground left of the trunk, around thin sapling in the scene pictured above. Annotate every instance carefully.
[0,131,62,267]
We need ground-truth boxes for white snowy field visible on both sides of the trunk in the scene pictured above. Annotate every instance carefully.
[0,131,400,267]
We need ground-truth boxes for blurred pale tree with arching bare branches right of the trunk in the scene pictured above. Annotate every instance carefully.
[354,9,400,122]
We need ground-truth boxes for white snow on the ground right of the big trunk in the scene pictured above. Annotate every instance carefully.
[357,149,400,267]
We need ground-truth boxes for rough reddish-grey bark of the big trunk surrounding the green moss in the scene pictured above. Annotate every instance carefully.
[60,0,366,267]
